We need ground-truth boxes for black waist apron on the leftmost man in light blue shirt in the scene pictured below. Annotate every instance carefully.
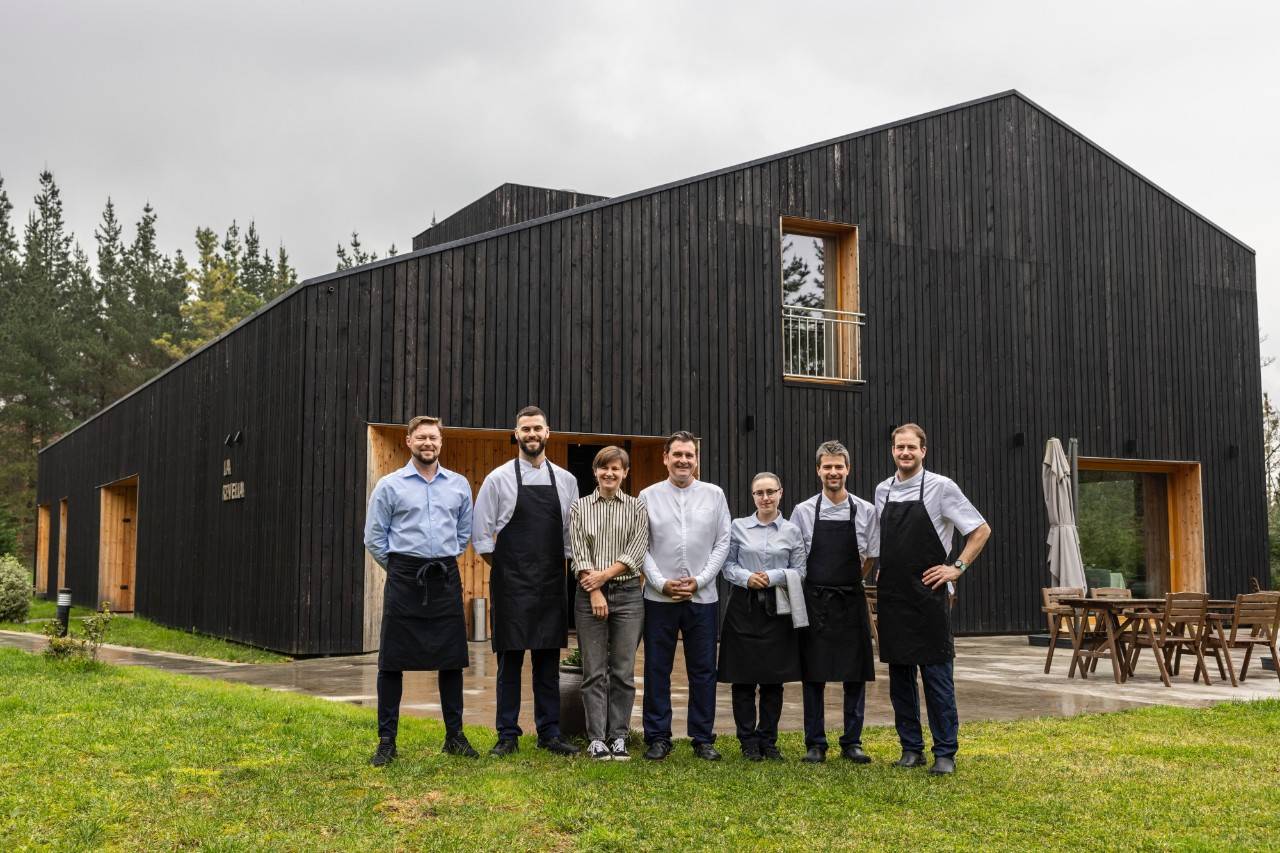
[378,553,468,671]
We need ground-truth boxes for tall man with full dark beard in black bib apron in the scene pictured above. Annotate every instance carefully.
[475,406,577,756]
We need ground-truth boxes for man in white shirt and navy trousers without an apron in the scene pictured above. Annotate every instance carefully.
[640,430,732,761]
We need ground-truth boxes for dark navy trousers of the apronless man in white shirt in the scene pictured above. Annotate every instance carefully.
[644,598,719,744]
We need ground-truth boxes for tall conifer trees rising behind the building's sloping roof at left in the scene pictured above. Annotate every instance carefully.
[0,170,297,561]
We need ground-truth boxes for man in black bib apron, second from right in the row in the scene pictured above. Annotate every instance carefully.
[791,442,876,765]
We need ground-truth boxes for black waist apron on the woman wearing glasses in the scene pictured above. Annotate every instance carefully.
[717,535,801,684]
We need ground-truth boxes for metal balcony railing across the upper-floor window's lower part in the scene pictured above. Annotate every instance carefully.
[782,305,865,382]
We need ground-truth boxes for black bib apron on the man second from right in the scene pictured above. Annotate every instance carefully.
[800,493,876,681]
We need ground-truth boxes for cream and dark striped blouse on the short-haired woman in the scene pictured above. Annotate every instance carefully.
[568,489,649,580]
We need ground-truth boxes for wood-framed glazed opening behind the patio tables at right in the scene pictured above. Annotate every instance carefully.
[1076,457,1204,598]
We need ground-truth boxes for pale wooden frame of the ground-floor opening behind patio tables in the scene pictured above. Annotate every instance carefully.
[1076,456,1207,592]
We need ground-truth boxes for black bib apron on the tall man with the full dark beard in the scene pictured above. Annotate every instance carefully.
[489,460,568,652]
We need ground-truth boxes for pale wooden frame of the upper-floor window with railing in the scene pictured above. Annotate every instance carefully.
[778,216,865,388]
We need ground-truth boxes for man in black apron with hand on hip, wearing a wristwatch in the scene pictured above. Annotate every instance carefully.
[872,424,991,774]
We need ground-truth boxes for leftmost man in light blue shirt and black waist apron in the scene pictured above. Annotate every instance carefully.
[365,415,476,767]
